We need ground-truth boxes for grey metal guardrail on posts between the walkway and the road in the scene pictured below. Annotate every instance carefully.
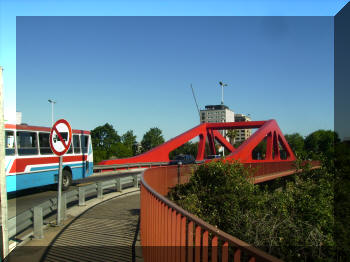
[8,174,140,239]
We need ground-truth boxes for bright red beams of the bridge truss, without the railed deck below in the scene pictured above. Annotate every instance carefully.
[99,120,295,165]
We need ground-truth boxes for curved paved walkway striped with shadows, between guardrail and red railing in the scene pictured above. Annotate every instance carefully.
[8,192,142,262]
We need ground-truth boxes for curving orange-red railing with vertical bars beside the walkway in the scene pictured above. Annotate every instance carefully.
[141,166,281,262]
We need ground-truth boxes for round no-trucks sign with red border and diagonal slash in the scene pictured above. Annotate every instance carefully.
[50,119,72,156]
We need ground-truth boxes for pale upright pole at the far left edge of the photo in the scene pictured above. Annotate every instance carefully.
[0,66,9,261]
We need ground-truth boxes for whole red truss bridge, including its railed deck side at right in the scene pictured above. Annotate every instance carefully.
[99,120,318,183]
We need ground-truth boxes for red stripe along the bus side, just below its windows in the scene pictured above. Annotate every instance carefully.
[10,155,87,173]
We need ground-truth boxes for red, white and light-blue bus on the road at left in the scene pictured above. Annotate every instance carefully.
[5,124,93,192]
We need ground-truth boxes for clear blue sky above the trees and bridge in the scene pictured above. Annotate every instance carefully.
[0,0,346,140]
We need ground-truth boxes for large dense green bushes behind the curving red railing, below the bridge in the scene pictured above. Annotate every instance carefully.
[169,162,335,261]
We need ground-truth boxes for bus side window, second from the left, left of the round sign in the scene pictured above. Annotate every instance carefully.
[17,131,38,156]
